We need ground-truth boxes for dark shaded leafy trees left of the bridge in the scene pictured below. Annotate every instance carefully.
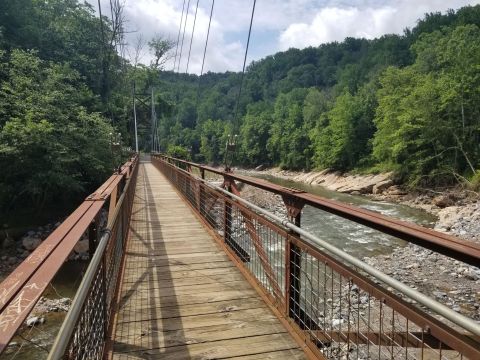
[0,0,131,224]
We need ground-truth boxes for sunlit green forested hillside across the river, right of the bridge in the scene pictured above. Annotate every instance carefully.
[156,6,480,185]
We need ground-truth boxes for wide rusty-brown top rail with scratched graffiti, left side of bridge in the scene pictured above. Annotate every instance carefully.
[0,156,138,354]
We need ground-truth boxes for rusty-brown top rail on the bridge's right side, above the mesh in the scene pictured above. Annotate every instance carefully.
[155,154,480,267]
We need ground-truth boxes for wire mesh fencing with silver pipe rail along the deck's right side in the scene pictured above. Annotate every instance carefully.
[154,159,480,360]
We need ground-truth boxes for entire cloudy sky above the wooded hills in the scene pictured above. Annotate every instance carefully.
[88,0,480,74]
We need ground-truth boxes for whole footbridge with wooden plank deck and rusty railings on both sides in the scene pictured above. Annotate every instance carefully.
[0,154,480,360]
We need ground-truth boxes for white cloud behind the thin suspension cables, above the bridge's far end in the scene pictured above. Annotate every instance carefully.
[90,0,248,74]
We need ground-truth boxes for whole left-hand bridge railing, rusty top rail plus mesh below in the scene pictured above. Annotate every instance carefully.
[0,156,138,359]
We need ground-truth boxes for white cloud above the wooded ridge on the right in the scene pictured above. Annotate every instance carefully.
[278,0,480,50]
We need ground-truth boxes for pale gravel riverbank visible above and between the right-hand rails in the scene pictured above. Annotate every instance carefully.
[242,179,480,320]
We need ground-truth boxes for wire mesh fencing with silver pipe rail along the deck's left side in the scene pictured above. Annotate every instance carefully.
[48,158,138,360]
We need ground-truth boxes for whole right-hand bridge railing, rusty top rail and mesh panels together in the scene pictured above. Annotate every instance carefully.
[152,156,480,360]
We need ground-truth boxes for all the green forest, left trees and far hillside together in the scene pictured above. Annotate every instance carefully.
[0,0,480,222]
